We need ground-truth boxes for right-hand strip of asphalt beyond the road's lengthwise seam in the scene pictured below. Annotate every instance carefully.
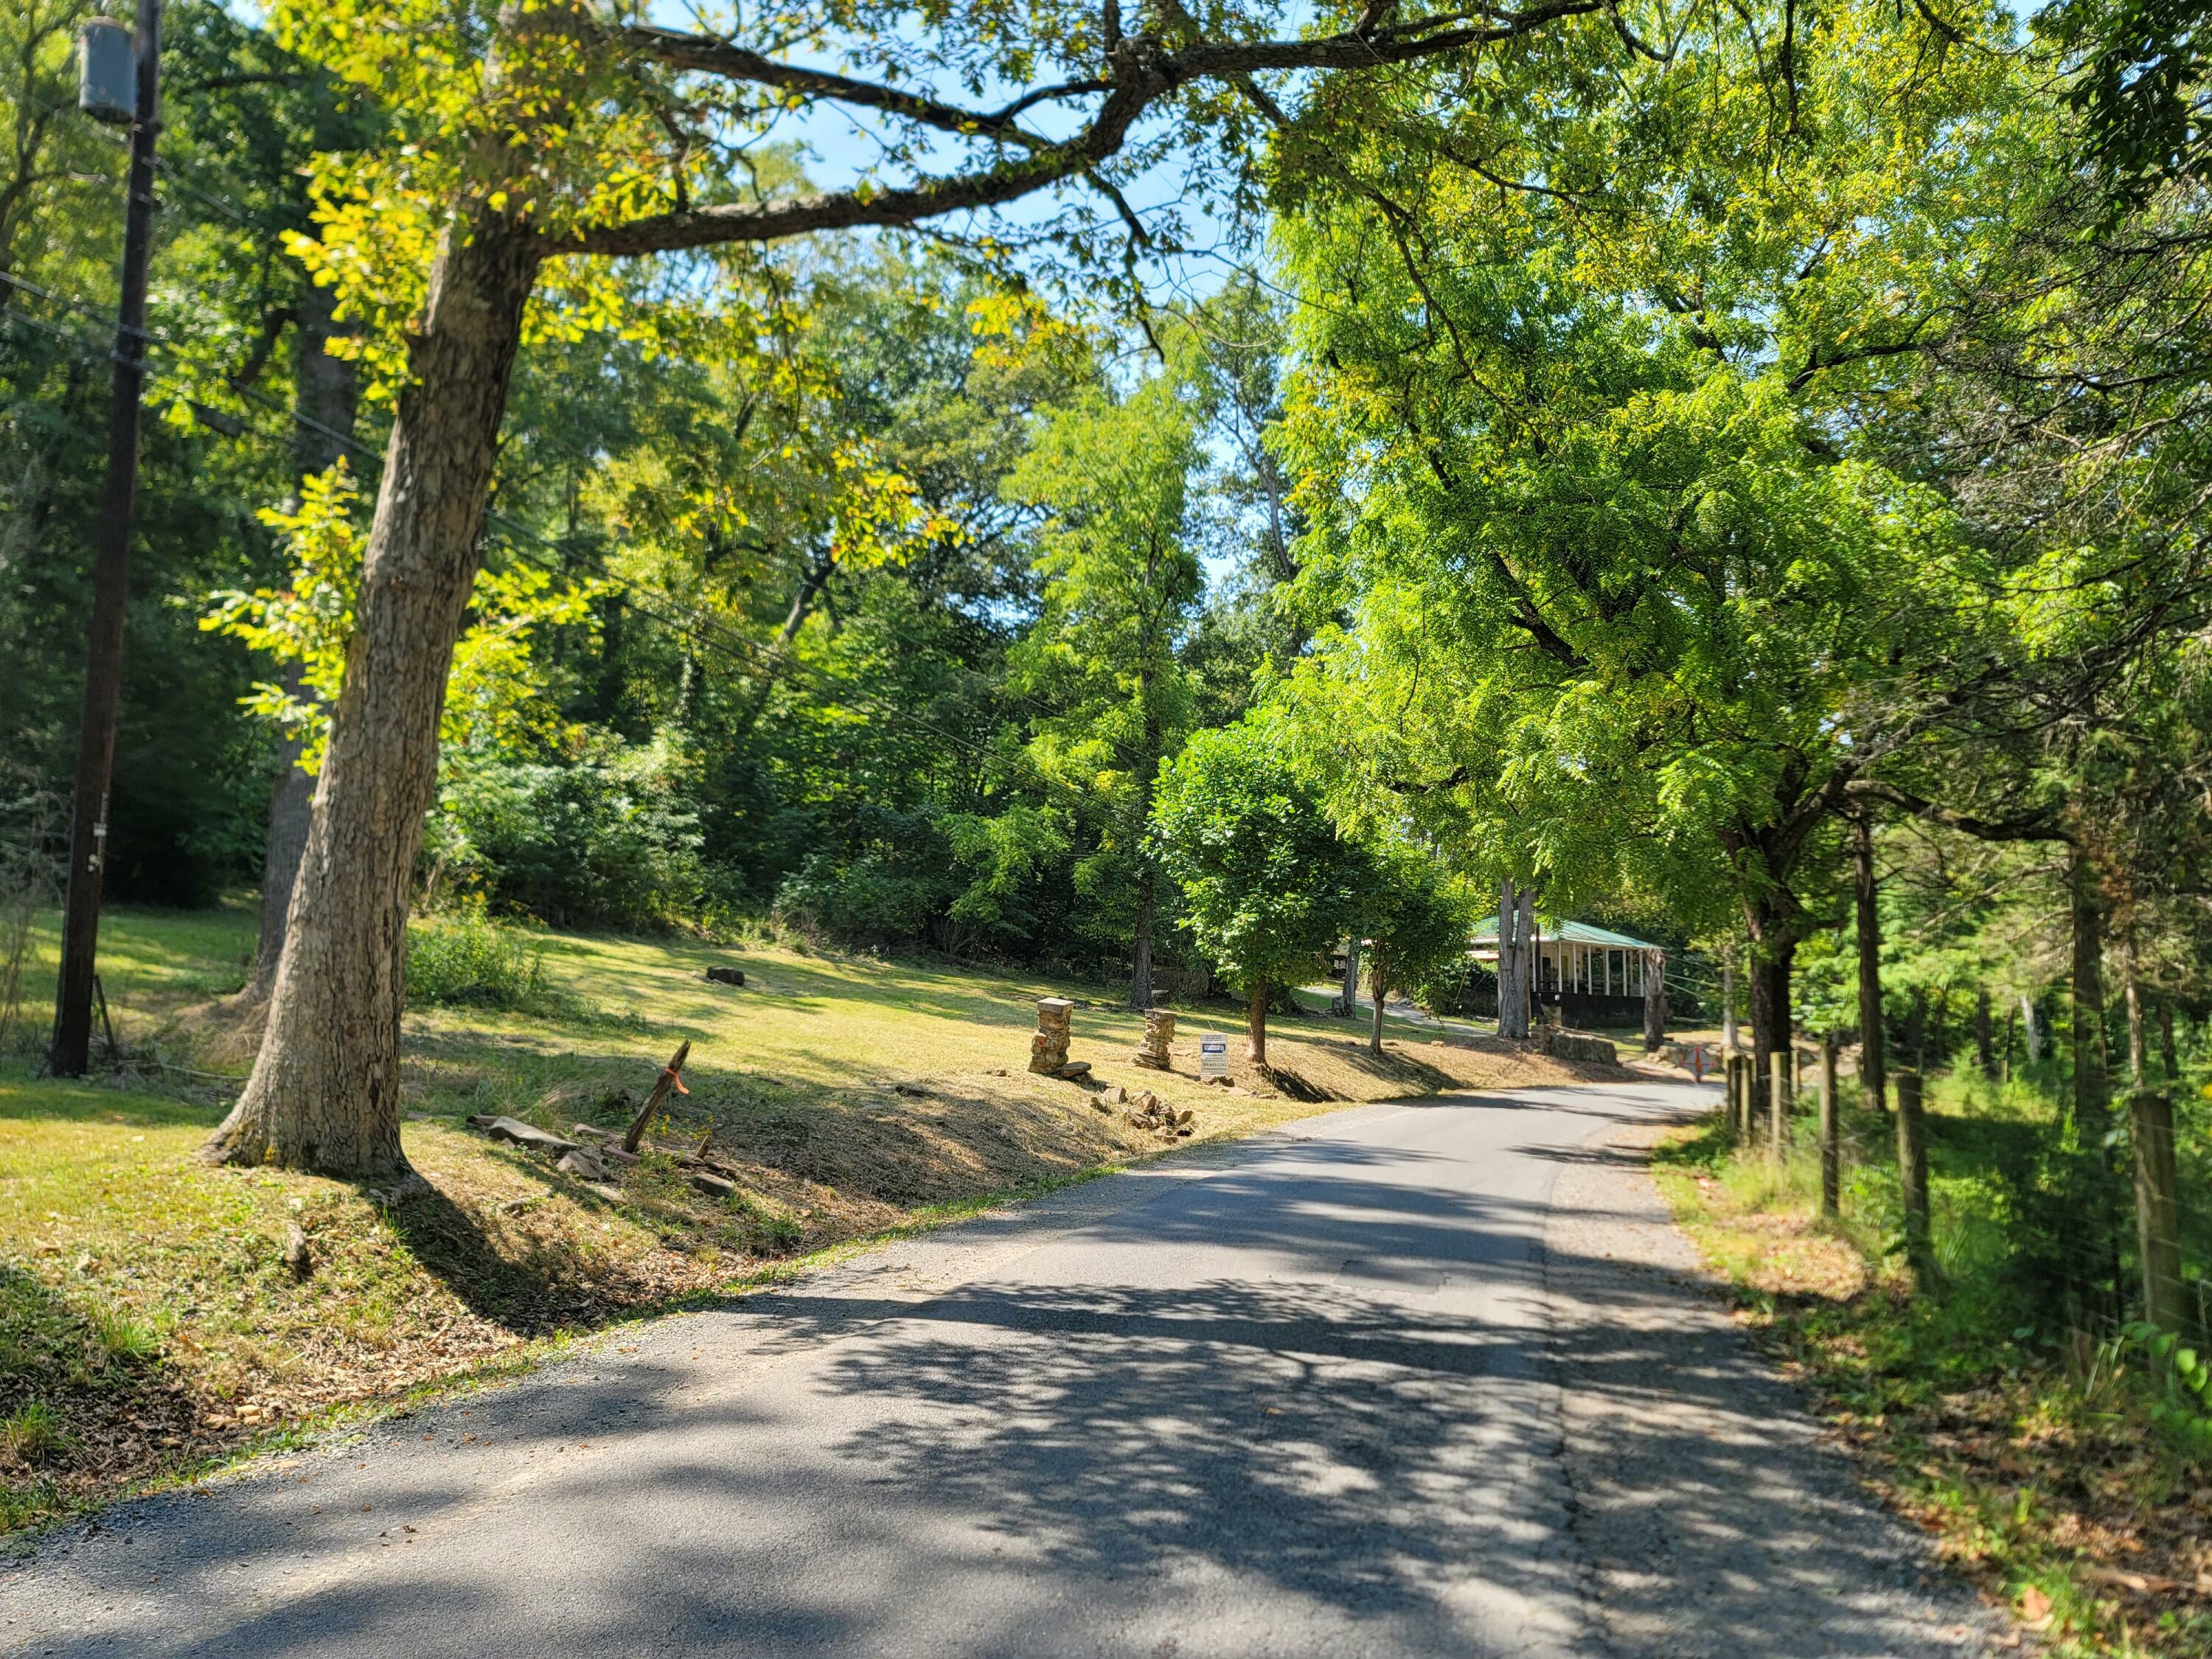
[1544,1106,2004,1659]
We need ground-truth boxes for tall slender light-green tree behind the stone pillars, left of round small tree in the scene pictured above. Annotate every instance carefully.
[1006,374,1203,1009]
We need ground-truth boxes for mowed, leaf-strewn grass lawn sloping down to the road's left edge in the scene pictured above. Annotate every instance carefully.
[0,907,1610,1531]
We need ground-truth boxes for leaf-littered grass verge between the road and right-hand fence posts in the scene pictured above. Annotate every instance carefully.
[1655,1097,2212,1659]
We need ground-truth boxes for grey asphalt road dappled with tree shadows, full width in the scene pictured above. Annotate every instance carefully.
[0,1082,1991,1659]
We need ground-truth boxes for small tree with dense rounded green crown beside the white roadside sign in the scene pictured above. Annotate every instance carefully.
[1152,721,1371,1066]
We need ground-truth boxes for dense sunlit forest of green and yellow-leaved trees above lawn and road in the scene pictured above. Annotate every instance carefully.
[0,0,2212,1380]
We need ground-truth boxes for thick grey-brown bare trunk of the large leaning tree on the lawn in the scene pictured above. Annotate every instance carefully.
[206,215,540,1179]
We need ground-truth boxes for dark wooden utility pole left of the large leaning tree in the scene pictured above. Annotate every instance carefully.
[49,0,161,1077]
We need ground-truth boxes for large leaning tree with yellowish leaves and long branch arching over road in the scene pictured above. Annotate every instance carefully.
[212,0,1604,1179]
